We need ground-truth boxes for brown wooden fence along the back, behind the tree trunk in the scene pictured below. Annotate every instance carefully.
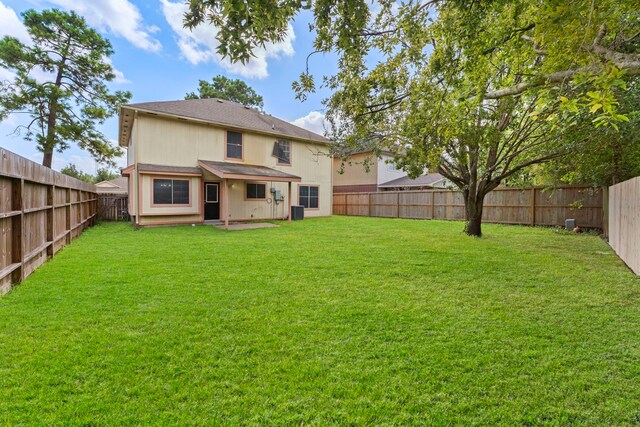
[333,186,603,228]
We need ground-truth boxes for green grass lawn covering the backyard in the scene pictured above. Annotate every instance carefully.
[0,217,640,425]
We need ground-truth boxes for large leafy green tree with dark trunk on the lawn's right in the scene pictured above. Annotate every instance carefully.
[185,0,640,236]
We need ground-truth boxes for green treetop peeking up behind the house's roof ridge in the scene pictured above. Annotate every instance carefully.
[184,76,264,110]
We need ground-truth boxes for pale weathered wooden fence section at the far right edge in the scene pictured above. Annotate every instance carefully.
[608,177,640,274]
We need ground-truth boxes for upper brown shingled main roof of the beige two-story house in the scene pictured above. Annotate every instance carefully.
[120,98,330,146]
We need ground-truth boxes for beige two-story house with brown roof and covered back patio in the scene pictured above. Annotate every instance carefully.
[119,98,333,226]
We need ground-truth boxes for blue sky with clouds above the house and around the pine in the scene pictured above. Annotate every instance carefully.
[0,0,335,173]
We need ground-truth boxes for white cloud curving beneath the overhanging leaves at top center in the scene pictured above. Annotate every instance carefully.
[161,0,295,79]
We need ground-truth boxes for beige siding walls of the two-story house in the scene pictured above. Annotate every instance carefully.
[131,114,333,221]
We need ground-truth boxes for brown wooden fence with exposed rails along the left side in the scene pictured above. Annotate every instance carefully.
[0,148,97,294]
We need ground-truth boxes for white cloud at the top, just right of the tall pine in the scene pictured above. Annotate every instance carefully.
[48,0,162,52]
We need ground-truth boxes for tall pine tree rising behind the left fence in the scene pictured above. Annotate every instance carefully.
[0,9,131,167]
